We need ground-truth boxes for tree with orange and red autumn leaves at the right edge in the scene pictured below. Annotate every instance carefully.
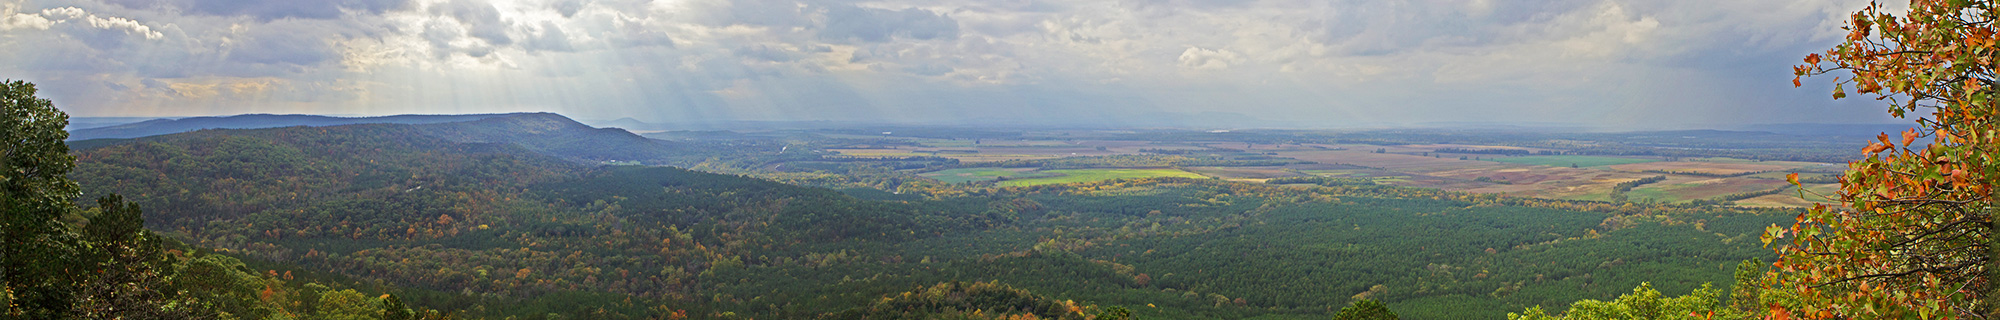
[1762,0,2000,318]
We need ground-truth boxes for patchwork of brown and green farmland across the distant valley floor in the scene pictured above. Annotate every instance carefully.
[872,136,1840,206]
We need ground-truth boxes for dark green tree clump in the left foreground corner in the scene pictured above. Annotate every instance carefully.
[0,80,206,318]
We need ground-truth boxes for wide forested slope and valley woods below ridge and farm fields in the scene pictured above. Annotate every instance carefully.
[47,118,1790,318]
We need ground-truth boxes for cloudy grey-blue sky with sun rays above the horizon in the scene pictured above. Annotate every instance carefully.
[0,0,1906,128]
